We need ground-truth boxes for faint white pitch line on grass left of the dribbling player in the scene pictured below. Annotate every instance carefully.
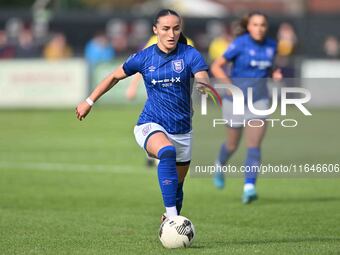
[0,161,139,173]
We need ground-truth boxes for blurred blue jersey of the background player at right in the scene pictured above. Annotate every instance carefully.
[223,33,277,101]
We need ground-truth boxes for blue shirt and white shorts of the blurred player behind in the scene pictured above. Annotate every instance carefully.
[223,33,277,127]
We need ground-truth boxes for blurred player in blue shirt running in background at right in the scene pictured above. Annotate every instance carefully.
[211,12,282,203]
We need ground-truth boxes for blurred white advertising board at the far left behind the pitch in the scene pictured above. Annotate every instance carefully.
[0,59,88,108]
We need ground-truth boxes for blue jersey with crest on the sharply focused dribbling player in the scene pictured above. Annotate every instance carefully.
[123,43,208,134]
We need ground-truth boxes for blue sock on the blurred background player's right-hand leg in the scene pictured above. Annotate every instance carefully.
[244,147,261,185]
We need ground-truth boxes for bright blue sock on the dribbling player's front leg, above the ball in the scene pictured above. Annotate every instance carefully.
[158,145,178,207]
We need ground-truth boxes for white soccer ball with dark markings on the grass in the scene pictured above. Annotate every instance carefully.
[159,216,196,249]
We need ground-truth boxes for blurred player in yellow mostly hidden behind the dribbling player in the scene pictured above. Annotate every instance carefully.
[125,25,194,167]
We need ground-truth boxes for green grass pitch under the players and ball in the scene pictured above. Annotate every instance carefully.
[0,106,340,255]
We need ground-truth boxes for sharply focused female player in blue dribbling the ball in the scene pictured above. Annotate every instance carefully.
[76,10,208,217]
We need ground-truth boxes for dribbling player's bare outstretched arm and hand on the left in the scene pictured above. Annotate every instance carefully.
[76,66,127,120]
